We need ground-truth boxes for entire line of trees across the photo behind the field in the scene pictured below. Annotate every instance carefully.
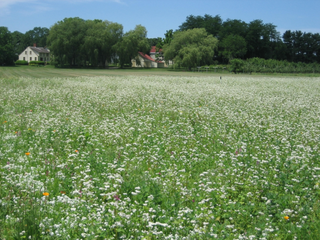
[0,14,320,69]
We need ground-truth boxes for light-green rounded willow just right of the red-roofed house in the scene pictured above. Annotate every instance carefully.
[163,28,218,70]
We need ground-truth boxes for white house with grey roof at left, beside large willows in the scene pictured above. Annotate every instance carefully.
[19,44,50,62]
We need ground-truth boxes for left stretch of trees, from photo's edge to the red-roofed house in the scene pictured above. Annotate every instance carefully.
[0,17,150,67]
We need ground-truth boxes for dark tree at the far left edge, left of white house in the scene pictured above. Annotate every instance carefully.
[0,27,14,66]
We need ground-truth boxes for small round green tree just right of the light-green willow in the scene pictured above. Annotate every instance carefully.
[219,35,247,61]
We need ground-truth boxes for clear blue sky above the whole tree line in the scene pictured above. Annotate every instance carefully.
[0,0,320,38]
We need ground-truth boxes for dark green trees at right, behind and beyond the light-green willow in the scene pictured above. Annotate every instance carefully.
[178,14,320,63]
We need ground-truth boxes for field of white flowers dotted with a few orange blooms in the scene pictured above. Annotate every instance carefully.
[0,76,320,240]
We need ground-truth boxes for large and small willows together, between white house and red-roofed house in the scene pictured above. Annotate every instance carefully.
[47,18,150,67]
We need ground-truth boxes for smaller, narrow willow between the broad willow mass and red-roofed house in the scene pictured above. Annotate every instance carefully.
[114,25,150,68]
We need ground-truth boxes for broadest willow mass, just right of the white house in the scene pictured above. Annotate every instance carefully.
[48,18,123,66]
